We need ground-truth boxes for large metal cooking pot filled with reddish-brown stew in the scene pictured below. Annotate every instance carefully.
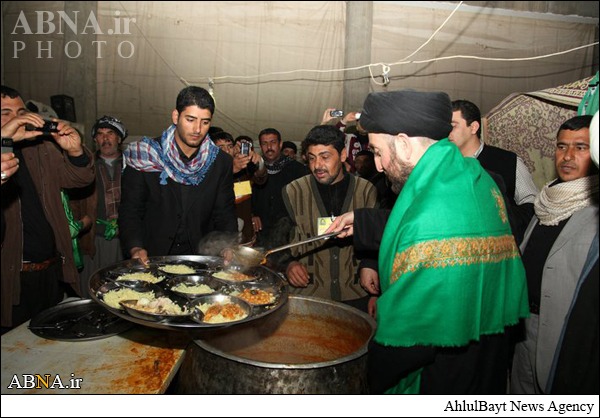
[175,295,376,394]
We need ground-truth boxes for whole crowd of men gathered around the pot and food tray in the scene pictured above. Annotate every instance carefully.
[1,79,599,394]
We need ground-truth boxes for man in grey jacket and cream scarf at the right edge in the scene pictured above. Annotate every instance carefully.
[511,115,598,394]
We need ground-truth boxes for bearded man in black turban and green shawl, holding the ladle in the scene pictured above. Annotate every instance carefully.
[327,90,528,394]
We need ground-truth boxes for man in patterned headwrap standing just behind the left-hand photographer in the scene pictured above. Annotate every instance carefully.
[69,116,127,296]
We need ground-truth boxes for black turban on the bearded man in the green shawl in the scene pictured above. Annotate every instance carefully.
[360,90,452,140]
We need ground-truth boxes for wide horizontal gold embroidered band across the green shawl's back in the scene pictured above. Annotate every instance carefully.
[390,235,519,283]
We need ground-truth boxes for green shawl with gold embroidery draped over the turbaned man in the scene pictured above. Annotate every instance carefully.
[375,139,529,393]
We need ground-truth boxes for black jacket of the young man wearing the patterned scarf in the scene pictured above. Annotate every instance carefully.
[119,151,237,256]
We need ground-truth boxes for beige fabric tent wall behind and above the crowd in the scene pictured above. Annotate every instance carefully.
[2,1,598,148]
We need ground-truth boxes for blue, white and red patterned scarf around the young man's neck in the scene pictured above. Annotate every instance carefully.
[123,124,219,186]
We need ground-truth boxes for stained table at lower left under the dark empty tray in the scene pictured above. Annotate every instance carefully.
[1,322,190,395]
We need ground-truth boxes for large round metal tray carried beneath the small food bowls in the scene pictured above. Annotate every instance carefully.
[89,255,288,330]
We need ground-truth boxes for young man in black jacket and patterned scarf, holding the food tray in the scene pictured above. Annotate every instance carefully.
[119,86,237,262]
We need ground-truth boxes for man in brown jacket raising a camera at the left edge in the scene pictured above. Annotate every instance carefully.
[1,86,95,333]
